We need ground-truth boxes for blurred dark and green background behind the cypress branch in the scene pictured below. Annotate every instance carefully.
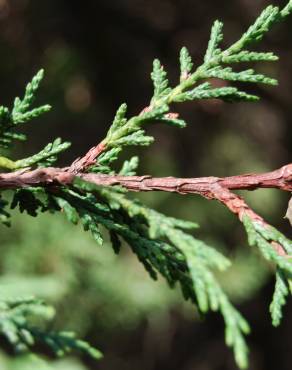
[0,0,292,370]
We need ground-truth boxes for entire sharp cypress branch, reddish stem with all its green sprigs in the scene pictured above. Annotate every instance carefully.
[0,0,292,368]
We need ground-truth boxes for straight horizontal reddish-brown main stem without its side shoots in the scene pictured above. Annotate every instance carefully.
[0,164,292,195]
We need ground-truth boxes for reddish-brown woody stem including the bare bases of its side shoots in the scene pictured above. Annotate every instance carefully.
[0,163,292,256]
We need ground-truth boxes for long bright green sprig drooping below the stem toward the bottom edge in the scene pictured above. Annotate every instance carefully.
[71,180,249,367]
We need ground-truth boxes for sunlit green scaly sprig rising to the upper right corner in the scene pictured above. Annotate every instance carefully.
[96,1,291,165]
